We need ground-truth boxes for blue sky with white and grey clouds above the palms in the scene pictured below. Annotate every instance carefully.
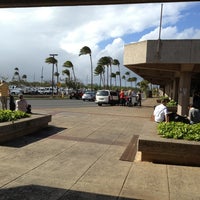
[0,2,200,84]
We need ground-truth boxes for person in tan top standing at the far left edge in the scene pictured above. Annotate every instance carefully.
[0,80,9,110]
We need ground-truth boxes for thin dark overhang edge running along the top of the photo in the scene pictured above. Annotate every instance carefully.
[0,0,198,8]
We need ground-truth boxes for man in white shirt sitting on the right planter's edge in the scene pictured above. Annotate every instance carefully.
[153,99,169,123]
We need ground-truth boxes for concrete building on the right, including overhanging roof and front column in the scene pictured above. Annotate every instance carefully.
[124,40,200,115]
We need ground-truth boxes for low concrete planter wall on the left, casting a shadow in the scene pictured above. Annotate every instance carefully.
[0,114,51,143]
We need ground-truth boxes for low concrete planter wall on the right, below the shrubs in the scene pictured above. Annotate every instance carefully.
[138,138,200,166]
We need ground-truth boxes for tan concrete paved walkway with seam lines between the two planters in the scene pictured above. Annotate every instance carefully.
[0,99,200,200]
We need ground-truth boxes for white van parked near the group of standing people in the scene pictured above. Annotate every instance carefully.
[95,90,119,106]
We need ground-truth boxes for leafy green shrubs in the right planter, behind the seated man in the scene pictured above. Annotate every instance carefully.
[158,122,200,141]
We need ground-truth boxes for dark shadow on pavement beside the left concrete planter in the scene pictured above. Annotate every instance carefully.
[1,125,66,148]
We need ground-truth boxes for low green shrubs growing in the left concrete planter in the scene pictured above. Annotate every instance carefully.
[0,110,30,122]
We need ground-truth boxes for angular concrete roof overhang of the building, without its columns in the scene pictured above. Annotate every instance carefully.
[124,40,200,85]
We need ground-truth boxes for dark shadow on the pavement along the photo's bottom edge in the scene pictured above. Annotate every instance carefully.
[0,185,141,200]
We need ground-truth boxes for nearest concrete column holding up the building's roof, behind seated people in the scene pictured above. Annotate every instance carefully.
[177,71,191,115]
